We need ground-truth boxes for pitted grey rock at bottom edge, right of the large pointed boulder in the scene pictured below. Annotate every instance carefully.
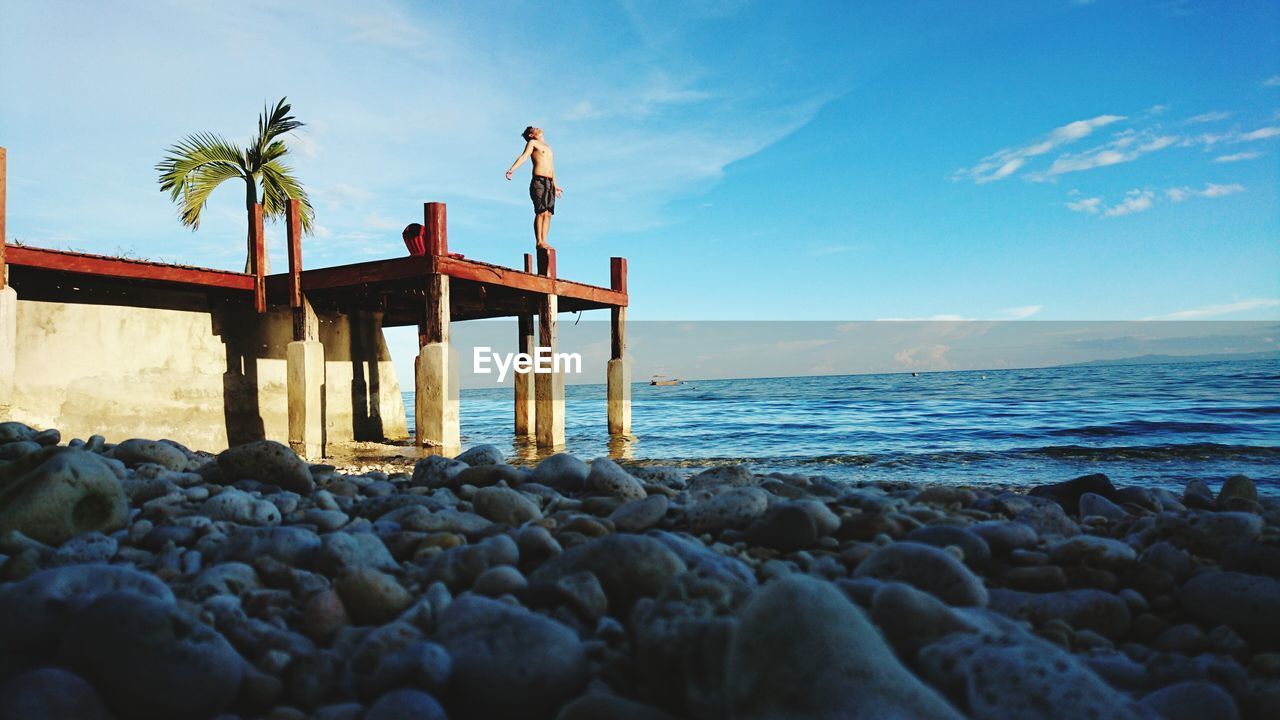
[918,622,1149,720]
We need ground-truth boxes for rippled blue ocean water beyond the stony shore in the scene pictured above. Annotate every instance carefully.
[406,360,1280,495]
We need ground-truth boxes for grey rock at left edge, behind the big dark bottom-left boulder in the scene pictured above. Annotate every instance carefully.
[0,565,173,659]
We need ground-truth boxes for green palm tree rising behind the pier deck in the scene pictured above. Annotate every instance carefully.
[156,97,315,273]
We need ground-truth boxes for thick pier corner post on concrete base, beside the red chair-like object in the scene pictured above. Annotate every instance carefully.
[413,202,461,454]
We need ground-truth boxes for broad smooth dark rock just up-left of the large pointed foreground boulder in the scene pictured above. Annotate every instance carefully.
[529,536,686,616]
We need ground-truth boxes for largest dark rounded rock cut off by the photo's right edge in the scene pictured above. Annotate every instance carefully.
[1178,571,1280,644]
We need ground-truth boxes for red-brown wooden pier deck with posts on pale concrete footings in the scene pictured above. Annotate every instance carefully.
[0,149,631,457]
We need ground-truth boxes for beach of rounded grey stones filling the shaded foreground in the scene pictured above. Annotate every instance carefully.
[0,423,1280,720]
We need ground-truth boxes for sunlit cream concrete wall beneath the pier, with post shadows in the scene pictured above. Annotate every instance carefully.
[0,296,408,452]
